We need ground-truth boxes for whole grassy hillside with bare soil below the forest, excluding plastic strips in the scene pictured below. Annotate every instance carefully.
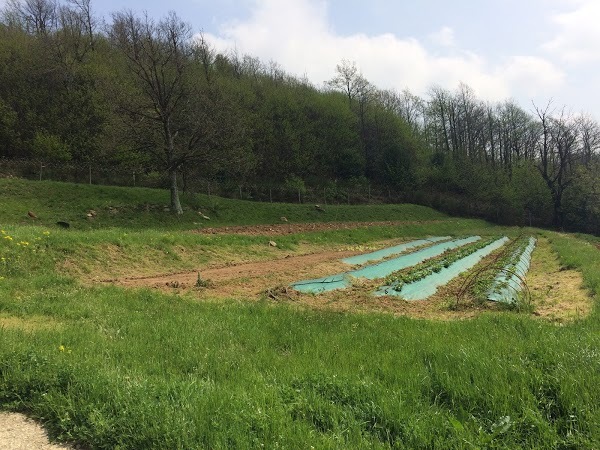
[0,179,600,449]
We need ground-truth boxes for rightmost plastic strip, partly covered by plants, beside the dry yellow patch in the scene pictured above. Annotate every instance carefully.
[487,237,536,304]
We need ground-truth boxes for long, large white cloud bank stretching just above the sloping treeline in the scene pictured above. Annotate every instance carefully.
[206,0,564,100]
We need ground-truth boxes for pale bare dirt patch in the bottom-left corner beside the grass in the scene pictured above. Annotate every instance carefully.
[0,413,72,450]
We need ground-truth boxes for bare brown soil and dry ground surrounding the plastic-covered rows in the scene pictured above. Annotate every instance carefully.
[109,239,592,322]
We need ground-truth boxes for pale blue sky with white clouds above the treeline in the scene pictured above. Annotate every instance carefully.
[0,0,600,120]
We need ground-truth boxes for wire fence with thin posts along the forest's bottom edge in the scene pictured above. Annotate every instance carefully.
[0,158,545,226]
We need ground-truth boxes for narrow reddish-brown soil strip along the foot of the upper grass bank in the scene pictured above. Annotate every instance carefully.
[193,220,442,236]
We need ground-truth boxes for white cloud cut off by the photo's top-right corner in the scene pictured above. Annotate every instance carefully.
[543,0,600,63]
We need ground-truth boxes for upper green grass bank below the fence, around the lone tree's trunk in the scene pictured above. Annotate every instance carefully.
[0,178,448,230]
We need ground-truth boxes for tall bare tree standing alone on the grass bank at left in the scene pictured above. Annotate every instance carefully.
[110,12,195,214]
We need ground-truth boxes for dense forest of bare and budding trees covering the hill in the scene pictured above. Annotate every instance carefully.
[0,0,600,235]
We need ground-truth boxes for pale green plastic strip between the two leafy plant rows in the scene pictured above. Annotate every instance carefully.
[375,237,508,300]
